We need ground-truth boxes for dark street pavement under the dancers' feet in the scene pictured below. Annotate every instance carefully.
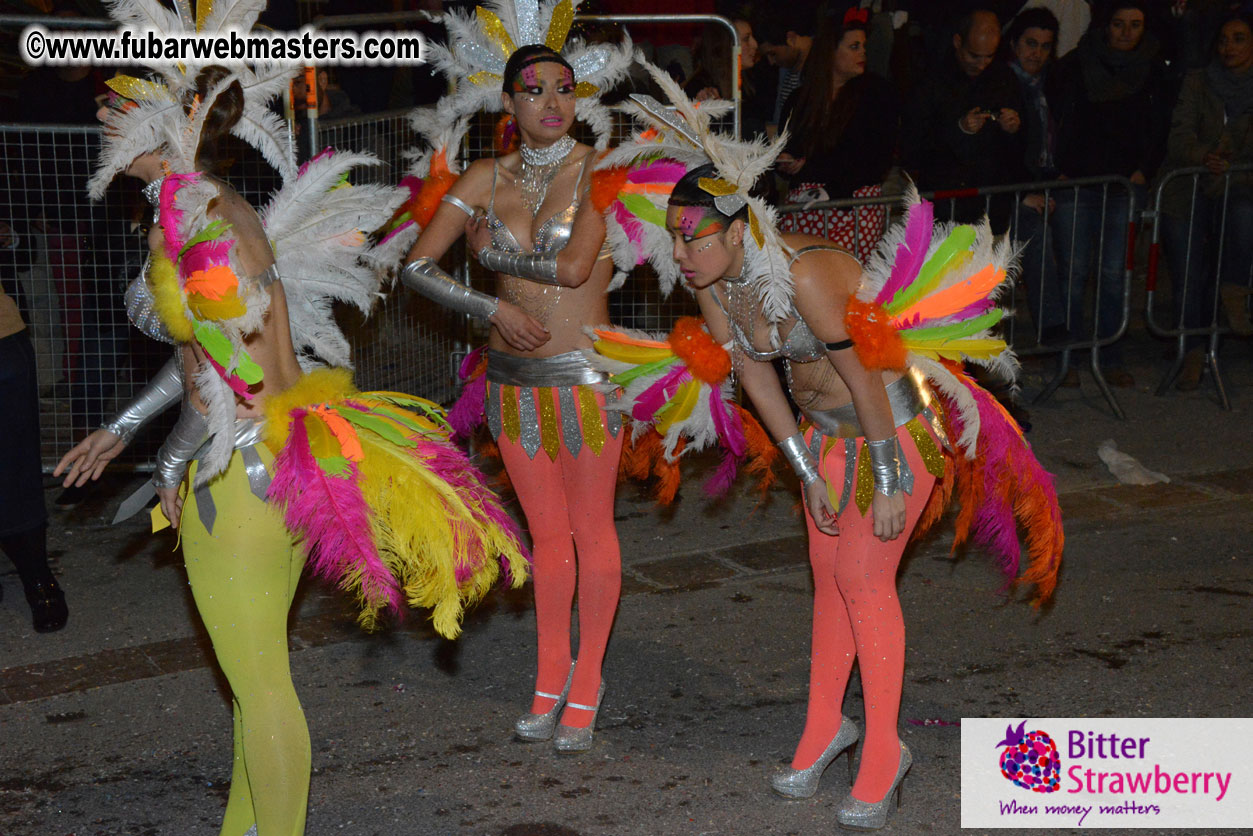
[0,346,1253,836]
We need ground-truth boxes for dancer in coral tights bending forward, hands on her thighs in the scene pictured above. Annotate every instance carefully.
[583,68,1063,830]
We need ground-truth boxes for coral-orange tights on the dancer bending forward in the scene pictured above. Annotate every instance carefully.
[792,427,935,802]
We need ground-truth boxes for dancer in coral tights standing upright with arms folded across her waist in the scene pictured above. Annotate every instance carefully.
[401,0,632,752]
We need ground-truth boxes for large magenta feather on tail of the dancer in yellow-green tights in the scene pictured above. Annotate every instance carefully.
[267,410,401,613]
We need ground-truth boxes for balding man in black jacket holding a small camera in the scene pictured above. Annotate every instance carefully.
[902,9,1022,231]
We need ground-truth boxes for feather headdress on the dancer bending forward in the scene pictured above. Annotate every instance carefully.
[596,55,792,326]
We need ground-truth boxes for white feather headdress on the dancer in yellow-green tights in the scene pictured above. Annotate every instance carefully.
[88,0,298,199]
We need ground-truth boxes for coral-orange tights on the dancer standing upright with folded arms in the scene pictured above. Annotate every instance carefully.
[497,401,630,728]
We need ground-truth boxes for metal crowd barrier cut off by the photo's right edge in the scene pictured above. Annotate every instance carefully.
[1145,163,1253,410]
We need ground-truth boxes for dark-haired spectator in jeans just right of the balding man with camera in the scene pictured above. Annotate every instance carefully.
[1006,6,1066,343]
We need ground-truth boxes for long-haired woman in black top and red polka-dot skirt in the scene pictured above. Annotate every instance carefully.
[778,6,898,262]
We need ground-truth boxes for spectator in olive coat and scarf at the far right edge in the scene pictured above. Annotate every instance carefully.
[1162,14,1253,391]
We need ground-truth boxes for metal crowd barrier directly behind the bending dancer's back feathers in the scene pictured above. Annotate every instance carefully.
[778,175,1136,419]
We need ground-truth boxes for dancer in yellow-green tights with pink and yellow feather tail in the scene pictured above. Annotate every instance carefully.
[56,0,528,836]
